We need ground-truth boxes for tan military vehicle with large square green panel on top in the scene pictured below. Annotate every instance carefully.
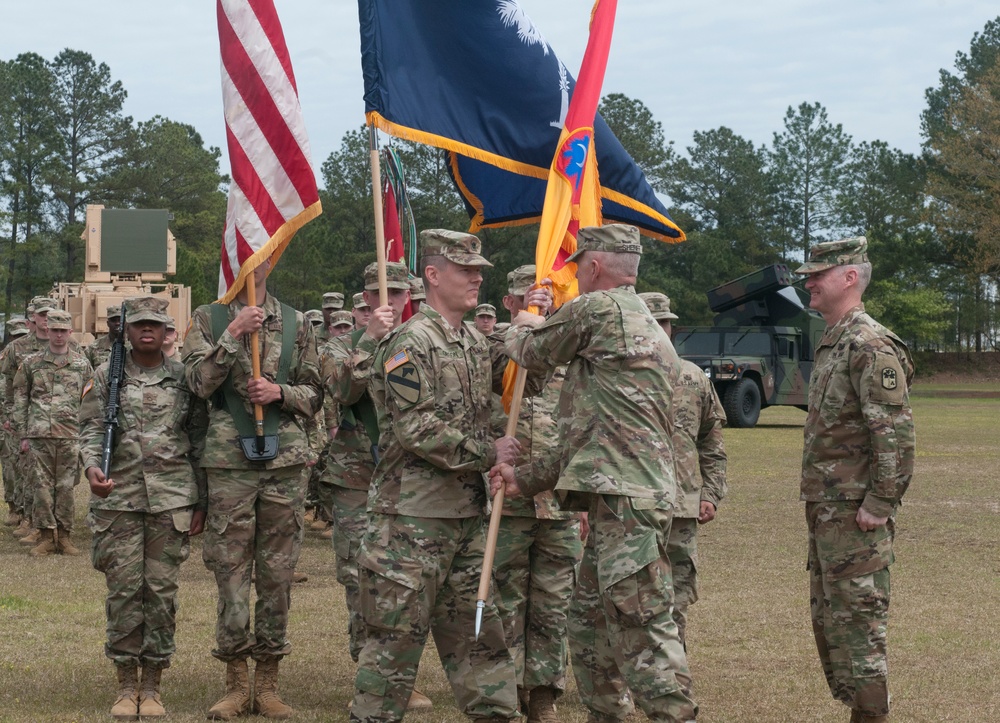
[50,205,191,344]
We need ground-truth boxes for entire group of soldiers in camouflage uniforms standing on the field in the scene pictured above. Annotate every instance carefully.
[0,225,913,723]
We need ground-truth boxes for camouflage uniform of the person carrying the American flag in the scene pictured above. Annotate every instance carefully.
[184,294,322,662]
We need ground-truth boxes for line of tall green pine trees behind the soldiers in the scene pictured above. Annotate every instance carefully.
[0,17,1000,351]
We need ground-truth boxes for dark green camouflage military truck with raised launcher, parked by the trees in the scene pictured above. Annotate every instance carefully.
[674,264,825,427]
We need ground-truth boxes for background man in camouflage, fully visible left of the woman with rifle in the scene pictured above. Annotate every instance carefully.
[14,309,93,555]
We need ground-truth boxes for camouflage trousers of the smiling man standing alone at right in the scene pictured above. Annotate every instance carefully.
[806,500,895,716]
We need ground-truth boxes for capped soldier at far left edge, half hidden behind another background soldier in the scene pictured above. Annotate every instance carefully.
[0,296,59,545]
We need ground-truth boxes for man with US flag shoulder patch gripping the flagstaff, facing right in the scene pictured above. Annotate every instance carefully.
[351,230,540,723]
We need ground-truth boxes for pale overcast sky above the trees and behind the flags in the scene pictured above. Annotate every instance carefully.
[7,0,1000,182]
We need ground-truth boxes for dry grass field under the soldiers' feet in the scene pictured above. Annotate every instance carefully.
[0,383,1000,723]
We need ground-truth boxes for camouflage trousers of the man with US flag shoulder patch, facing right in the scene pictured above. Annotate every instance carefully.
[351,514,518,723]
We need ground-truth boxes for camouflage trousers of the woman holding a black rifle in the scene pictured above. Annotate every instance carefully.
[87,507,192,668]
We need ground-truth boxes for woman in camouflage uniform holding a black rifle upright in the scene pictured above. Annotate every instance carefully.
[80,296,208,719]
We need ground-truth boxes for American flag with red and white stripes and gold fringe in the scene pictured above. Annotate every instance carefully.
[217,0,322,303]
